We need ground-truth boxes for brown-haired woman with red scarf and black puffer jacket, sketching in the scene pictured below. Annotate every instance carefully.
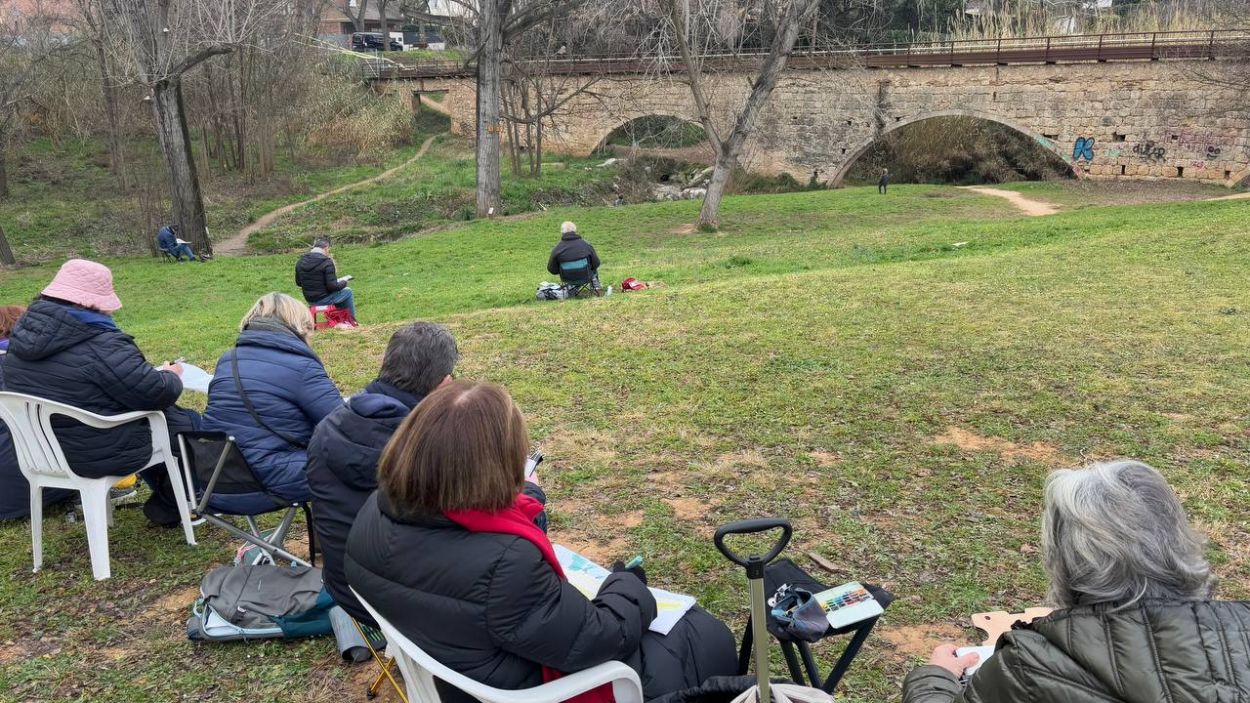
[345,382,738,703]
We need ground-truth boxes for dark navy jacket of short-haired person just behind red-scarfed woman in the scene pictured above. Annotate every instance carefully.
[308,380,421,622]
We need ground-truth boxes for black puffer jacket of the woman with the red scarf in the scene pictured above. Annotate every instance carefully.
[346,494,656,703]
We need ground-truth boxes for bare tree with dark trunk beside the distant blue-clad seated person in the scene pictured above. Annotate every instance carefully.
[104,0,281,253]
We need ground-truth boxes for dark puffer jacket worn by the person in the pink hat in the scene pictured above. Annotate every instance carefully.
[4,300,183,478]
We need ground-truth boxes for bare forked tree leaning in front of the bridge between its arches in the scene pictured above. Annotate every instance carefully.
[661,0,819,228]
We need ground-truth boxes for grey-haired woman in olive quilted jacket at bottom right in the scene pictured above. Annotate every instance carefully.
[903,462,1250,703]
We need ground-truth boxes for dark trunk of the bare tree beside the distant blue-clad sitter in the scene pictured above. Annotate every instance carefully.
[153,78,213,254]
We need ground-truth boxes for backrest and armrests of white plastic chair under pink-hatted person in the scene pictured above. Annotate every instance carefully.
[0,392,161,478]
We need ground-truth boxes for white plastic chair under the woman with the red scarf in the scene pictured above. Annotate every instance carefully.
[351,588,643,703]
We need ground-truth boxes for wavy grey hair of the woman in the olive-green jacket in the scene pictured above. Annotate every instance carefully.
[1041,460,1214,608]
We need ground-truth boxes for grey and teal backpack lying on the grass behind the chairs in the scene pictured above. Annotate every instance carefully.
[186,564,335,642]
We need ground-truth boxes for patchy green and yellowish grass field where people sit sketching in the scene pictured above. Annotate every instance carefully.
[0,185,1250,703]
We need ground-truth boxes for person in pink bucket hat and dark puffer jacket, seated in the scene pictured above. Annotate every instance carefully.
[3,259,200,527]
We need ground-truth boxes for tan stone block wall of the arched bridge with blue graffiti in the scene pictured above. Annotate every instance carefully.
[420,56,1250,185]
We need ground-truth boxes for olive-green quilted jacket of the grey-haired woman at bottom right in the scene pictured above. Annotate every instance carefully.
[903,600,1250,703]
